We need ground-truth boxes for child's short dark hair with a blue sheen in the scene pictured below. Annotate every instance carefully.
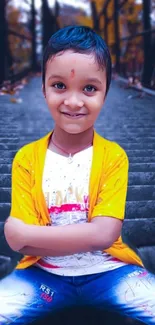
[42,26,111,94]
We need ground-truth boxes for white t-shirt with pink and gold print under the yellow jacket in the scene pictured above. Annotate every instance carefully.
[36,147,126,276]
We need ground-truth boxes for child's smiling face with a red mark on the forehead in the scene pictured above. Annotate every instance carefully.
[44,51,106,134]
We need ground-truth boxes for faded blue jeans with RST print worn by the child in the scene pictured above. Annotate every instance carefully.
[0,265,155,325]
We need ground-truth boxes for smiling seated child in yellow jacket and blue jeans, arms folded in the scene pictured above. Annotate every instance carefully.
[0,26,155,325]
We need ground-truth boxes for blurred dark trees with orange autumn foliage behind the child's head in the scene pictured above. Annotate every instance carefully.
[0,0,155,88]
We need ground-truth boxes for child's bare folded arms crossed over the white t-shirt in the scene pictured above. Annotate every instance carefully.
[5,217,122,256]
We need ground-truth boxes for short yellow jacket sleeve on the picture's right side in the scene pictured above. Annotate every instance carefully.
[92,144,129,220]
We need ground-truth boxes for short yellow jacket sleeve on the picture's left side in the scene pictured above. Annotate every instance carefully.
[10,144,38,224]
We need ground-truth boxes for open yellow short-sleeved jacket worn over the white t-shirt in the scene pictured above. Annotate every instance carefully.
[10,132,142,269]
